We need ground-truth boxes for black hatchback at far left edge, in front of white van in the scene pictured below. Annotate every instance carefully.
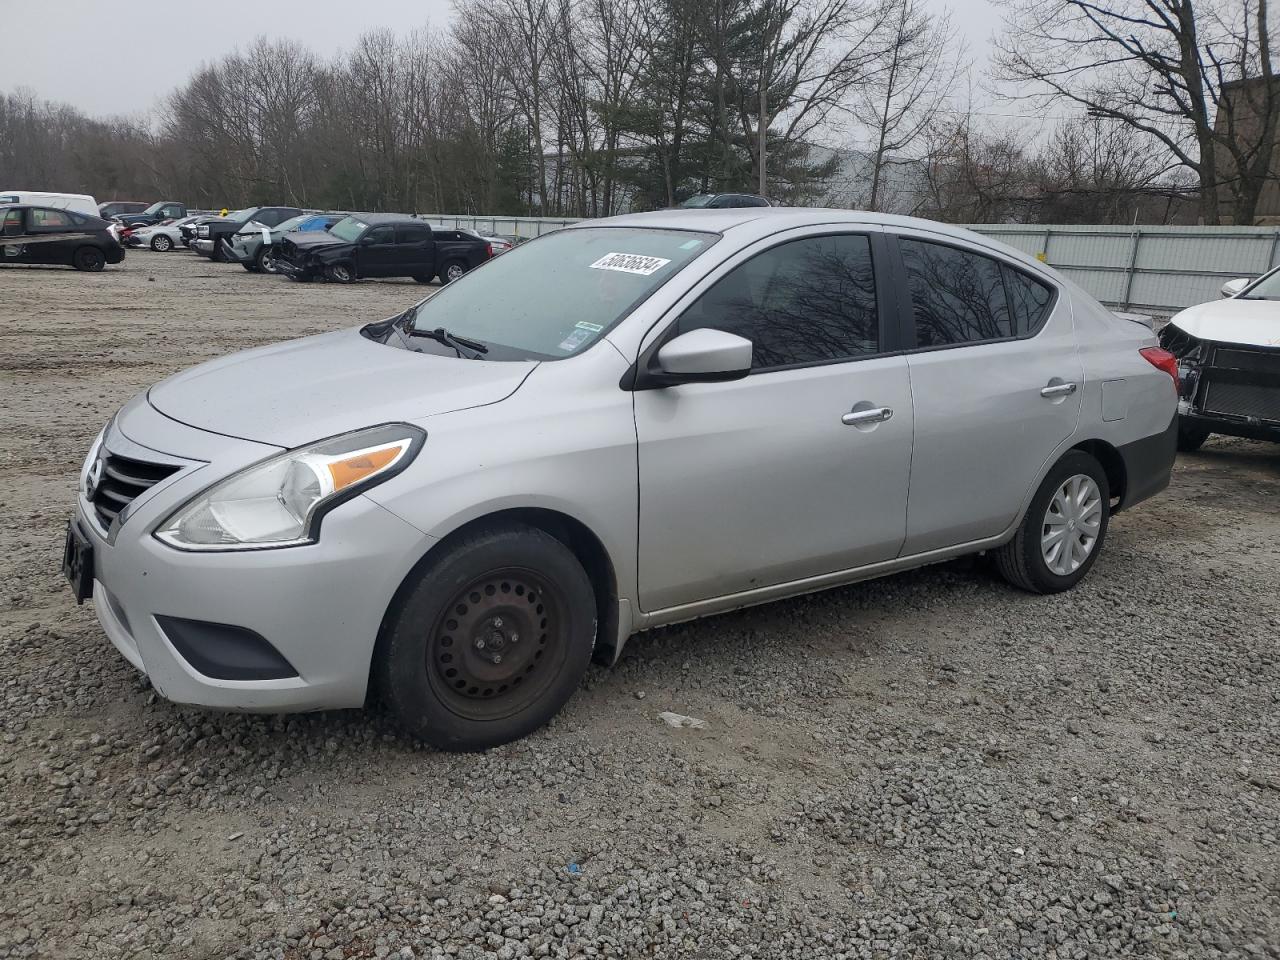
[0,204,124,273]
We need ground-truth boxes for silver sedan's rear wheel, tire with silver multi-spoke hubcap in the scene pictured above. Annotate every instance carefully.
[995,451,1111,594]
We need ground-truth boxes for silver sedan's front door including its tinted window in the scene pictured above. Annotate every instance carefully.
[635,233,913,613]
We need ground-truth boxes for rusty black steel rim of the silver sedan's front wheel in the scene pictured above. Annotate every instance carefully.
[426,567,568,721]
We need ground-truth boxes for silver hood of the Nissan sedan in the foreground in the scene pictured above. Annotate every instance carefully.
[147,330,538,447]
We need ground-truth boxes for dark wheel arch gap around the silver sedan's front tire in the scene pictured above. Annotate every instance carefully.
[378,507,630,680]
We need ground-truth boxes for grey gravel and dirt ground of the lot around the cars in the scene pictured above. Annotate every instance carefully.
[0,252,1280,960]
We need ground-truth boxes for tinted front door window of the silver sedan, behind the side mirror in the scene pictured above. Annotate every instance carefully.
[680,234,879,370]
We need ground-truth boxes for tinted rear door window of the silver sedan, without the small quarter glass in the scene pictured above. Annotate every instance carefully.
[899,239,1012,347]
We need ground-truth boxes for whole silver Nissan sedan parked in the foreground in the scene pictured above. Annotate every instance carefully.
[64,207,1178,749]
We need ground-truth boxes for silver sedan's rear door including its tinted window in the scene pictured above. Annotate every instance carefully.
[896,232,1084,554]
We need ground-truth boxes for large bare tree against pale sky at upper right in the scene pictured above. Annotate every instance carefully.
[995,0,1280,224]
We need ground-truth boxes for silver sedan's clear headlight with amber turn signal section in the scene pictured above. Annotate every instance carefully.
[155,424,426,550]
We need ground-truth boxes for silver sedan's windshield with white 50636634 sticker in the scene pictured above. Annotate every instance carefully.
[404,227,719,360]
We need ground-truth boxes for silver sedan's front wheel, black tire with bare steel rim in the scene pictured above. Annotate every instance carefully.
[371,525,595,750]
